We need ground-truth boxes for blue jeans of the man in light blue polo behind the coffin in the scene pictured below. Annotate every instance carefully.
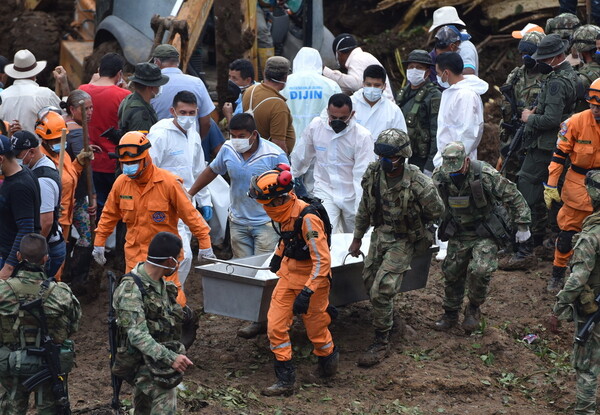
[229,221,279,258]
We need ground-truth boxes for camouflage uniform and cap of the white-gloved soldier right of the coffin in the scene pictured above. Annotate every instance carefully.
[433,142,531,328]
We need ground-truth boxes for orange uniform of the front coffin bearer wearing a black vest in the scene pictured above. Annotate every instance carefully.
[267,194,334,361]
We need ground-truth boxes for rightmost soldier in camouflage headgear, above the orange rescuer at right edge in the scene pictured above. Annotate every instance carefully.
[572,24,600,112]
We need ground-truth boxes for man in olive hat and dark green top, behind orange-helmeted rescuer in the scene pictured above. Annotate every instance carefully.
[118,62,169,133]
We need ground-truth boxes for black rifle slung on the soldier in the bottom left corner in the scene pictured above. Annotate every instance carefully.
[20,298,71,415]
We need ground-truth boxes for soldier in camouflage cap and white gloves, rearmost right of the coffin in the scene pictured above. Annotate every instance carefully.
[433,141,531,333]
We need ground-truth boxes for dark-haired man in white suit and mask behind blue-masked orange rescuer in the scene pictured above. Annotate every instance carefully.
[147,91,213,287]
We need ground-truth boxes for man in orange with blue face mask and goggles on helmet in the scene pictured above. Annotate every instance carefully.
[92,131,214,307]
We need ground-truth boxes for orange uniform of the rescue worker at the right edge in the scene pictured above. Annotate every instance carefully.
[548,110,600,267]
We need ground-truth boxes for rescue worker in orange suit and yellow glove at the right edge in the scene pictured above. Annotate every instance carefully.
[544,79,600,292]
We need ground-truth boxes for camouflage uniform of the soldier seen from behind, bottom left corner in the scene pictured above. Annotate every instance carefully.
[0,263,81,415]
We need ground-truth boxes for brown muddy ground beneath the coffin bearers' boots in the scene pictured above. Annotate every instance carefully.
[63,261,575,415]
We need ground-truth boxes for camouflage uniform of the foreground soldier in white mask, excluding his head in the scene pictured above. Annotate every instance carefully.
[113,262,183,415]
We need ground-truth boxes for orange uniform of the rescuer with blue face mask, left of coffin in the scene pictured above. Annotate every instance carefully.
[94,164,211,307]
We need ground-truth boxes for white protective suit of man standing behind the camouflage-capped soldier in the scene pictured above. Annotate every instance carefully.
[433,75,488,167]
